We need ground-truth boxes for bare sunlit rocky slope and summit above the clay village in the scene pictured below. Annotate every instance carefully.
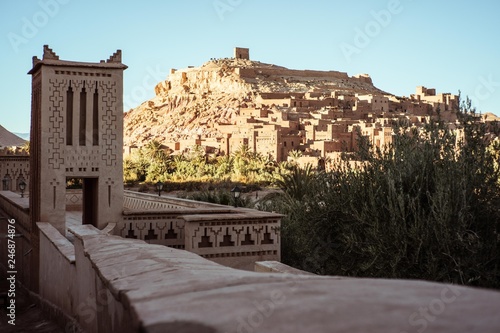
[124,58,384,146]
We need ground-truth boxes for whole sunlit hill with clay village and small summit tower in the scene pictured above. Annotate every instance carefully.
[124,48,458,164]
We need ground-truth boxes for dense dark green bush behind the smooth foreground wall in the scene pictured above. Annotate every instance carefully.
[260,106,500,288]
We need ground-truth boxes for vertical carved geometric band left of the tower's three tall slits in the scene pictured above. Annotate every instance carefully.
[48,80,66,169]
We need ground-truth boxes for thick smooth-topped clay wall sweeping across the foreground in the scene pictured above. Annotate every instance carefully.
[39,220,500,333]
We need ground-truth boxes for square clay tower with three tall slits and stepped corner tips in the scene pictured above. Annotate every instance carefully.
[28,45,127,235]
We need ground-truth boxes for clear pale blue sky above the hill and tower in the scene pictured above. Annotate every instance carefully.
[0,0,500,132]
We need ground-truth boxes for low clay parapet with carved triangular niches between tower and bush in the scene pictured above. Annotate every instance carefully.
[119,192,282,270]
